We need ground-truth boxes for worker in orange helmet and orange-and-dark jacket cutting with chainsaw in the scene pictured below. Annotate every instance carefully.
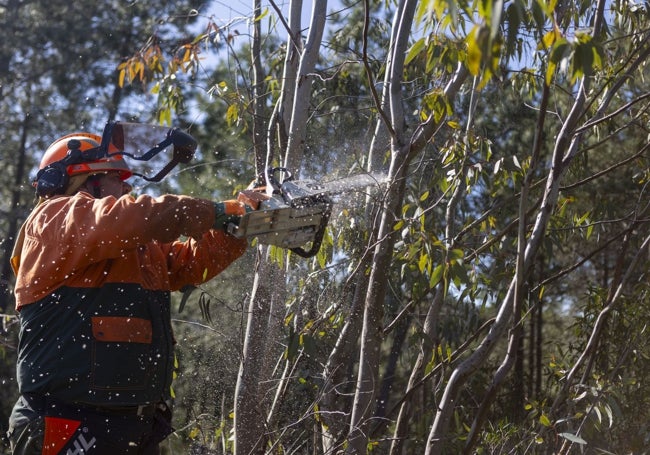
[7,133,247,455]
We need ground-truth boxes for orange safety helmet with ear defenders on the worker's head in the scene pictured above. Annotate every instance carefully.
[33,133,133,197]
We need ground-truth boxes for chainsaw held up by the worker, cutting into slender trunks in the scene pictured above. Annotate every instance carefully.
[227,167,384,258]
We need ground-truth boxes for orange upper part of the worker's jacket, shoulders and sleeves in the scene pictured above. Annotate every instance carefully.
[12,193,247,307]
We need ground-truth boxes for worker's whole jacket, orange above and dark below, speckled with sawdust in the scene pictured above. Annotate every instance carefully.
[12,192,247,406]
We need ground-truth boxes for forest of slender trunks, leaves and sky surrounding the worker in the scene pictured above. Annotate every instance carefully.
[0,0,650,454]
